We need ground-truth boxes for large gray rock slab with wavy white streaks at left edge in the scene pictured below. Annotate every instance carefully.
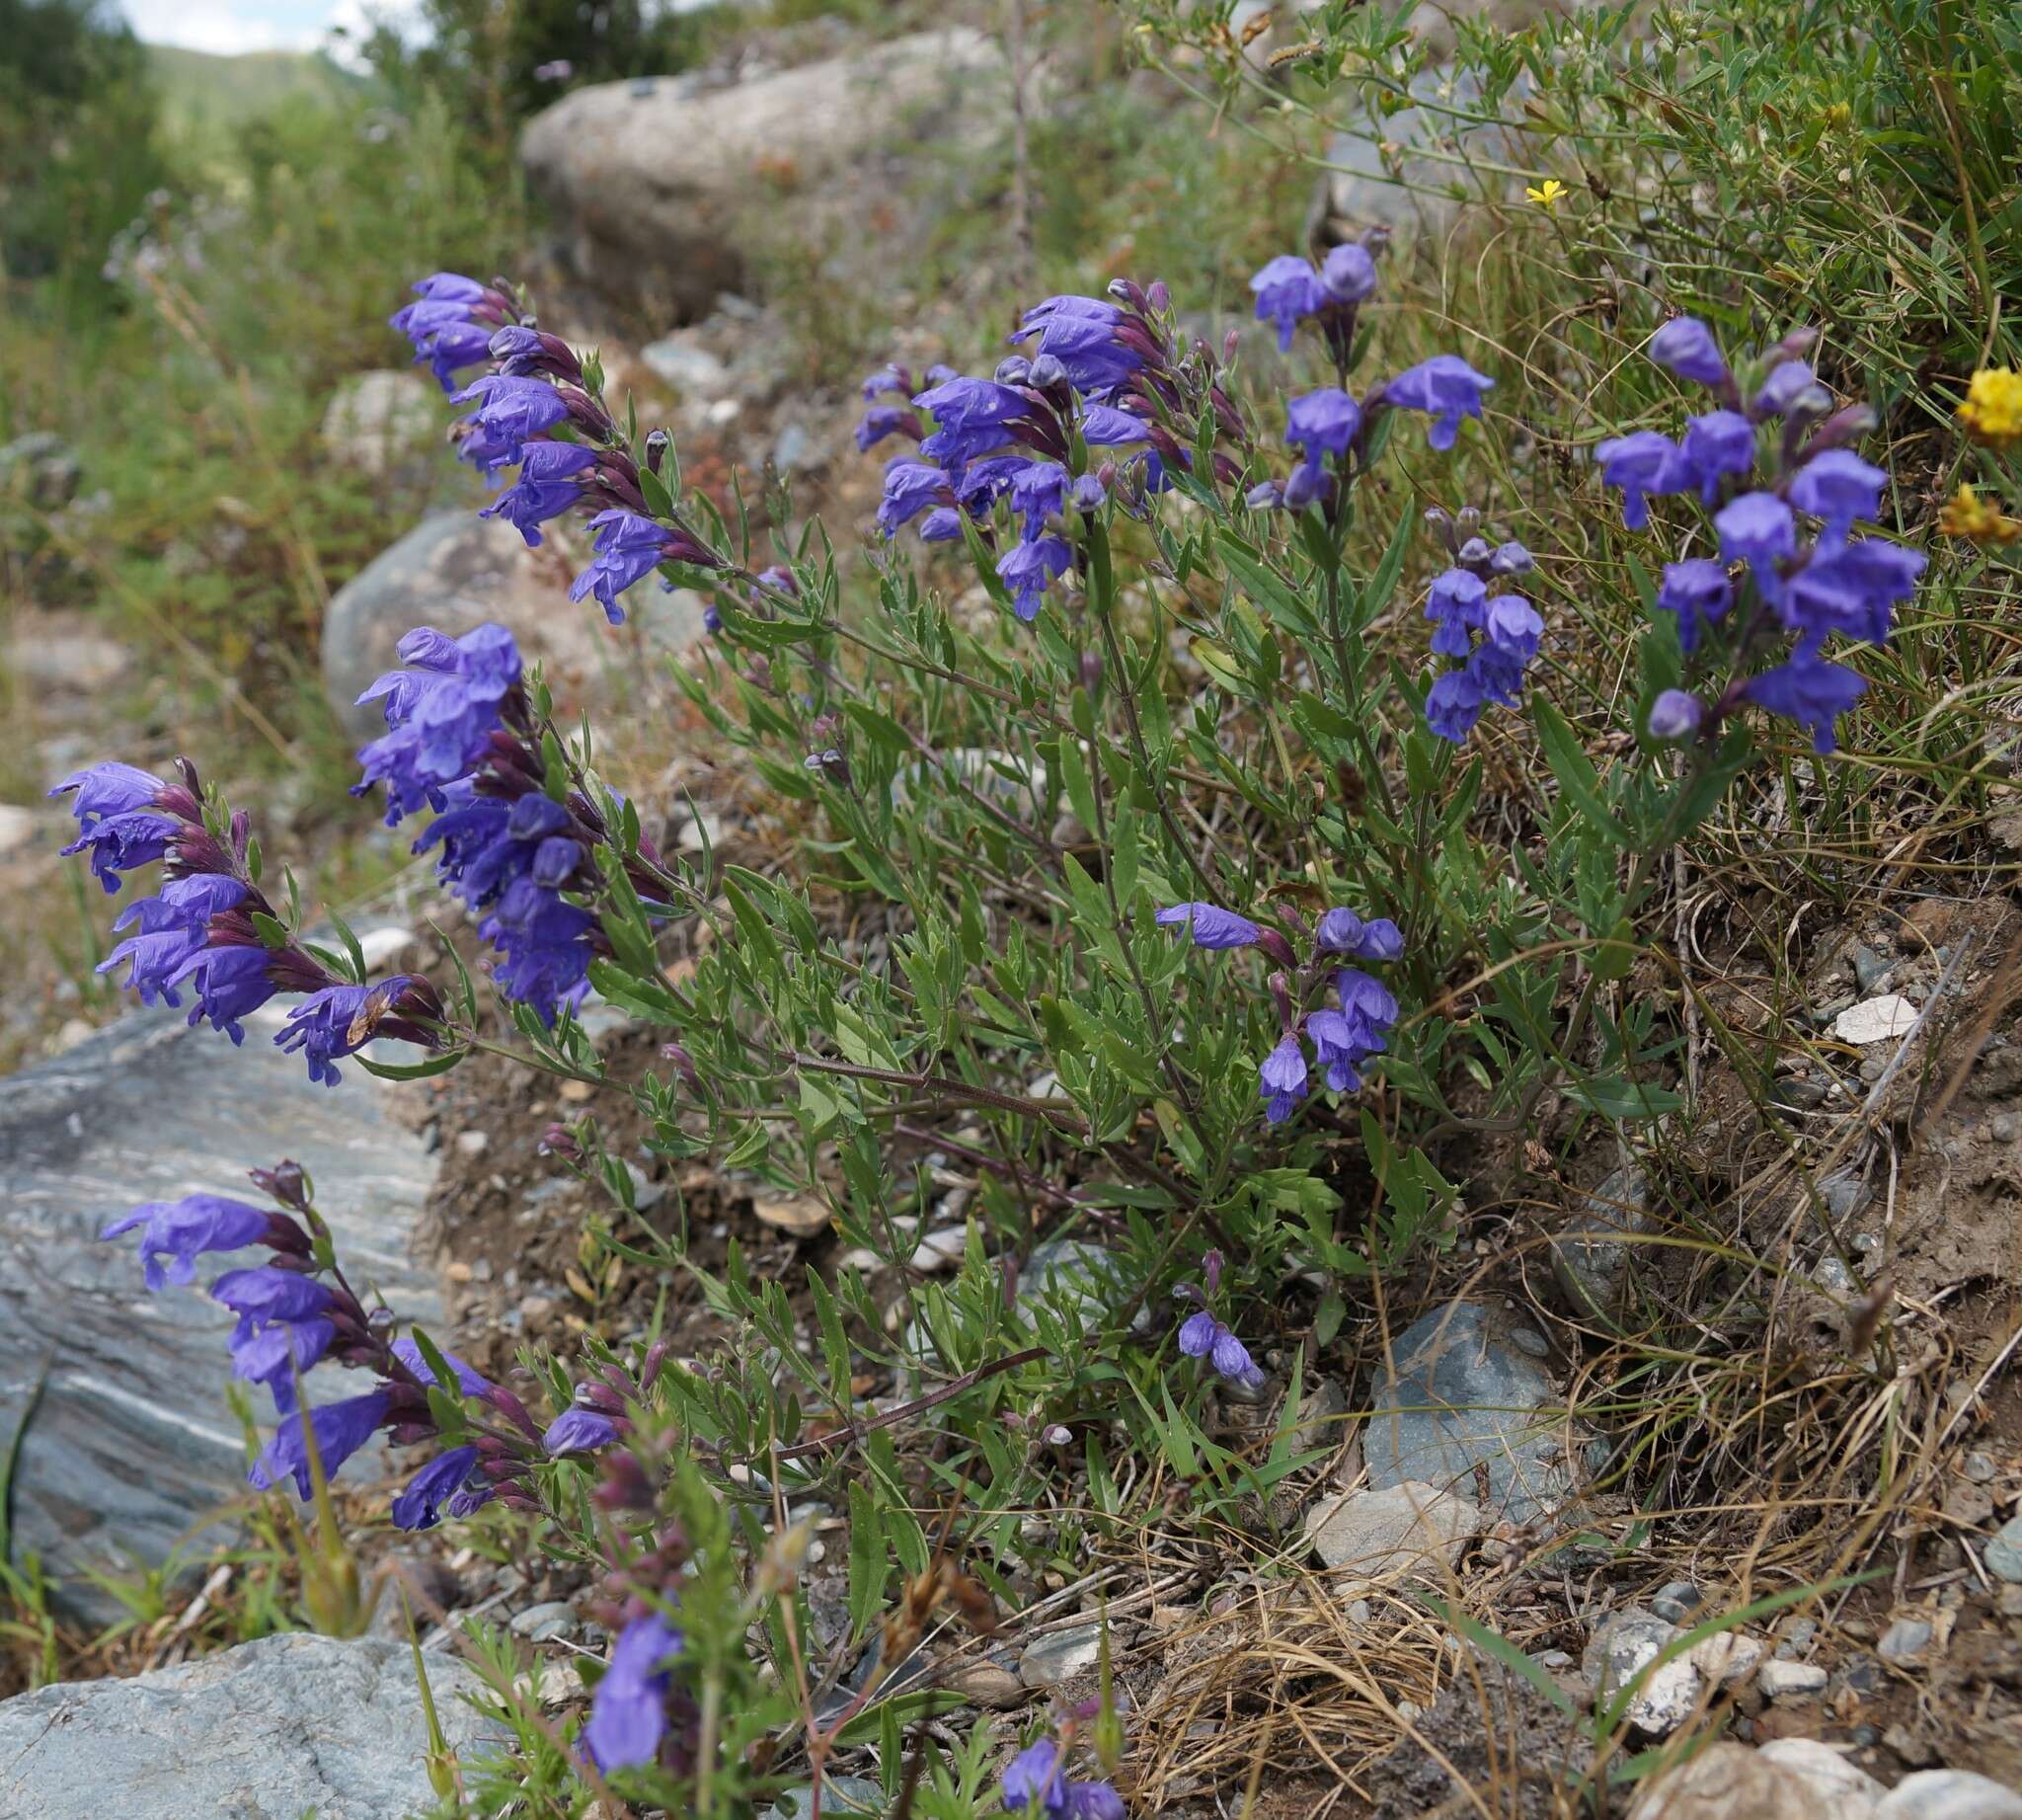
[0,1011,440,1618]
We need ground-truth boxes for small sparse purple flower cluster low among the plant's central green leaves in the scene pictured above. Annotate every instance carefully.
[1159,904,1403,1125]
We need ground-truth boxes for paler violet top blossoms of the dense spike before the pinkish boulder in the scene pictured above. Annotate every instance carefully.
[351,625,519,828]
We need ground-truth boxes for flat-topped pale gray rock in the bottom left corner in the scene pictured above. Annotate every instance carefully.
[0,1634,500,1820]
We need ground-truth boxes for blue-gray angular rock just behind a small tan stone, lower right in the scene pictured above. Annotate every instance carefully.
[1362,1303,1571,1523]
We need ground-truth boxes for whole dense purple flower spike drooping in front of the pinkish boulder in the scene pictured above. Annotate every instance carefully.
[353,625,651,1023]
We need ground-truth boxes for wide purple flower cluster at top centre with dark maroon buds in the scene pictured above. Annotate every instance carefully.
[857,279,1241,623]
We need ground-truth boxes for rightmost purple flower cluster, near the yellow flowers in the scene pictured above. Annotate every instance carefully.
[1595,315,1925,752]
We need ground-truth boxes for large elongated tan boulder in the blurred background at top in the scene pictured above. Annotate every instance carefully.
[519,27,1009,326]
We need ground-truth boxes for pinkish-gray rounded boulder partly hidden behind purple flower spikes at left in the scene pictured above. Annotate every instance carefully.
[324,512,702,740]
